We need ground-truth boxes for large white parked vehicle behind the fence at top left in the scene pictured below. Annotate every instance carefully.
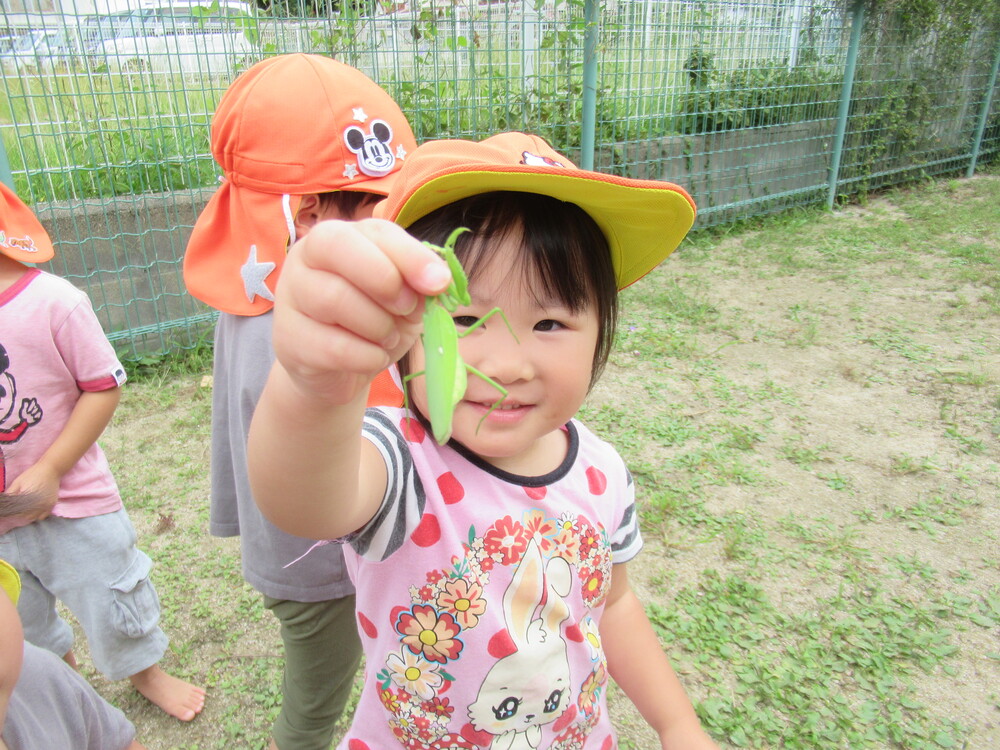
[86,0,254,75]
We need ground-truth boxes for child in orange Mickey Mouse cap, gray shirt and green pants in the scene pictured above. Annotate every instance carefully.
[184,54,416,750]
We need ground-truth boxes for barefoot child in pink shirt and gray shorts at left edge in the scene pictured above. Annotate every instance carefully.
[0,185,205,721]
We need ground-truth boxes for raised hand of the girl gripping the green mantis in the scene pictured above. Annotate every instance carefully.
[273,219,451,404]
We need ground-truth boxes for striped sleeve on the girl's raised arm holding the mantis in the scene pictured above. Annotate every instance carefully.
[344,409,426,562]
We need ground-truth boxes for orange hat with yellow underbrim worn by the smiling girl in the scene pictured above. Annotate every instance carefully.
[375,132,696,289]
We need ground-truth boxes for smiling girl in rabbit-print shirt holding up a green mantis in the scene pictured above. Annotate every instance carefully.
[250,133,715,750]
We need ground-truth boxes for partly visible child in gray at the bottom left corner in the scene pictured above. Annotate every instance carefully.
[0,560,143,750]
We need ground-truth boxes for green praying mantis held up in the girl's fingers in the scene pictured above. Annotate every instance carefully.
[403,227,517,445]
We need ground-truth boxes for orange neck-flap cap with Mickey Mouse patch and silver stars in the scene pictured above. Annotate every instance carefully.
[184,54,416,315]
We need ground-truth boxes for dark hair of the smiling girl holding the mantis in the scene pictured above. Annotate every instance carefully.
[400,191,618,386]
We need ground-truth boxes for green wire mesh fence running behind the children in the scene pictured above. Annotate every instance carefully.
[0,0,1000,358]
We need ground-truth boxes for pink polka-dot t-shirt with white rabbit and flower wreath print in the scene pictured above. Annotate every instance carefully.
[339,408,642,750]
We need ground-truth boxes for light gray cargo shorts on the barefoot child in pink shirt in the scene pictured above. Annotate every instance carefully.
[0,509,167,680]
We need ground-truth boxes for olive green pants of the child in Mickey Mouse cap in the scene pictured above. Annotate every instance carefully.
[264,595,361,750]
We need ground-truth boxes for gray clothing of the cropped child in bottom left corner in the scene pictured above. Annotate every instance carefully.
[2,643,135,750]
